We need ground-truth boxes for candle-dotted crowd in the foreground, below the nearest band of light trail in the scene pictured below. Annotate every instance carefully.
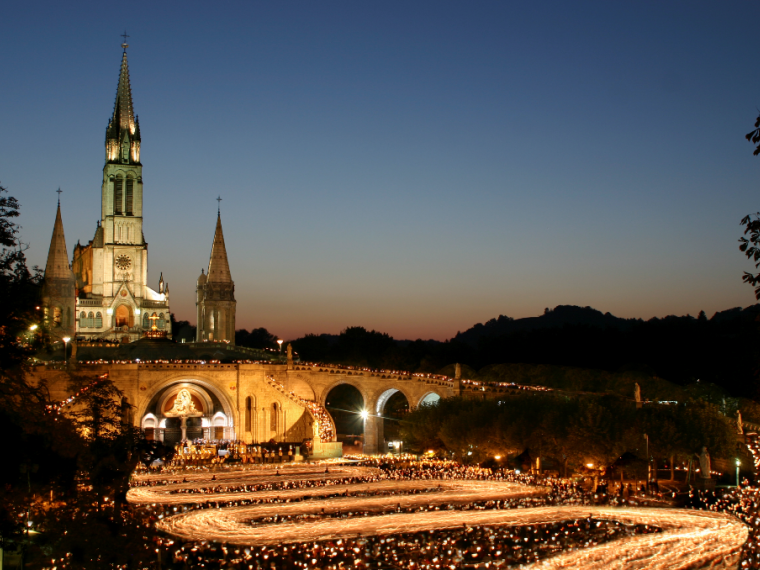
[148,518,659,570]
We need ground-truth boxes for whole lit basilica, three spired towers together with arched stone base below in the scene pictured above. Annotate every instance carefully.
[30,44,452,457]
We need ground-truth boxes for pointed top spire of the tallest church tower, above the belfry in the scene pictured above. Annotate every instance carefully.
[106,43,140,164]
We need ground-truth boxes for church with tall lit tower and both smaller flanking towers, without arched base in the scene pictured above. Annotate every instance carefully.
[42,44,236,343]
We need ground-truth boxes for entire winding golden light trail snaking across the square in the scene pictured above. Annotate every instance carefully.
[127,466,748,570]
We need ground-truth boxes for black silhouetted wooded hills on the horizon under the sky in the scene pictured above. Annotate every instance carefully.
[293,305,760,397]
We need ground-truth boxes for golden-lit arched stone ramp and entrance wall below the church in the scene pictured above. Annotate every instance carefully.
[32,361,462,453]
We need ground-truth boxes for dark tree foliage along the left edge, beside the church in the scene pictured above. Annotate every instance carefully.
[0,187,160,568]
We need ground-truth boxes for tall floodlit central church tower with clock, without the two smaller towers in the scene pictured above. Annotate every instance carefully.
[73,43,171,342]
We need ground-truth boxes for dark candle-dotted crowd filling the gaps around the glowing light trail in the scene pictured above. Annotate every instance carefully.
[117,440,760,570]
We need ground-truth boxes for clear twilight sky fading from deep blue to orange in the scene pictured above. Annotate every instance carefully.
[0,0,760,339]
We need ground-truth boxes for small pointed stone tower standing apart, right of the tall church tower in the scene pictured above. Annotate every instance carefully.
[196,212,237,344]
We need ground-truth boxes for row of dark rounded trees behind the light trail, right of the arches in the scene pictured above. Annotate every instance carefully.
[401,392,736,469]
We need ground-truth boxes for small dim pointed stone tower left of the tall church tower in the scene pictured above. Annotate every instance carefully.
[41,195,76,339]
